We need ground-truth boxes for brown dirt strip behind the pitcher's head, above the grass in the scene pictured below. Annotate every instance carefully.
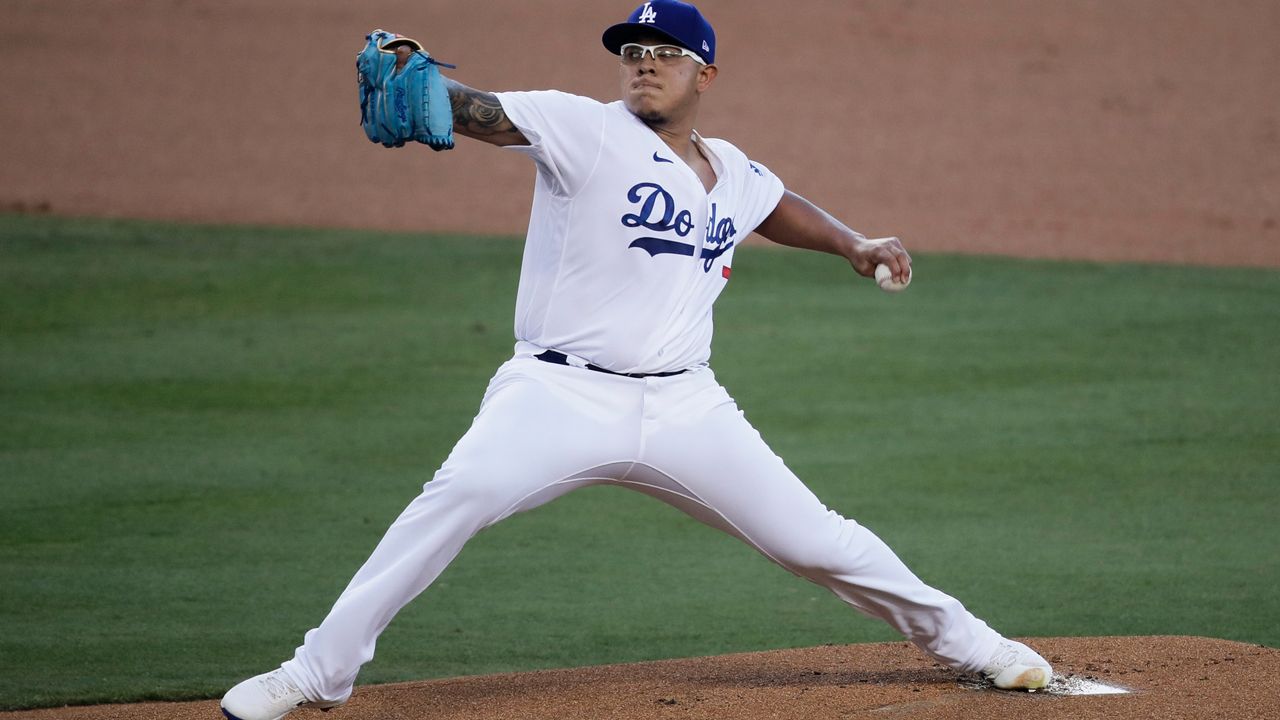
[0,0,1280,266]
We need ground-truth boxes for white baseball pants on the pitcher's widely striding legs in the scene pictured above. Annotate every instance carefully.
[283,352,1001,701]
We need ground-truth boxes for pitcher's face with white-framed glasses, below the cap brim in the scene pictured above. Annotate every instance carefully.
[618,35,717,124]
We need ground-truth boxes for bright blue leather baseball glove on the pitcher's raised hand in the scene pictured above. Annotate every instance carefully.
[356,29,454,150]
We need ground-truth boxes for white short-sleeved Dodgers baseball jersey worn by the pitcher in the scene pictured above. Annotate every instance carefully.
[498,91,782,373]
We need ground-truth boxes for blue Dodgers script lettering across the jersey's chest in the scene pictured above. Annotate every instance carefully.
[622,182,737,273]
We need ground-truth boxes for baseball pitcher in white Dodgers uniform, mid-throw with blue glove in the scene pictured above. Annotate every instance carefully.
[221,0,1052,720]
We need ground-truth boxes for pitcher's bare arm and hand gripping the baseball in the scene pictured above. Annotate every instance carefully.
[755,190,911,282]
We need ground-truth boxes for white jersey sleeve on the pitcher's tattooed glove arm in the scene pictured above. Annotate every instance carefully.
[494,90,605,196]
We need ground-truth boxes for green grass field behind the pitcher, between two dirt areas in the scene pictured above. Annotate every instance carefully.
[0,217,1280,708]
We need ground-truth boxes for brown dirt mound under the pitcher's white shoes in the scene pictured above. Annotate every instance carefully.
[0,637,1280,720]
